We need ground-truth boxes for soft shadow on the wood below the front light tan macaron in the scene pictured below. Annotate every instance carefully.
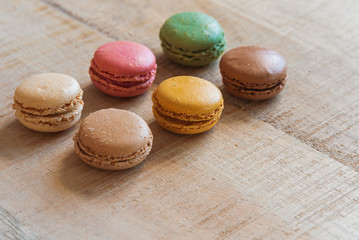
[53,119,200,199]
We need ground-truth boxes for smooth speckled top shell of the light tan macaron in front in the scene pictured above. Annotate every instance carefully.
[78,108,151,156]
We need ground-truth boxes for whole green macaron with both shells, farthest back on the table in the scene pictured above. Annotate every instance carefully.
[160,12,226,67]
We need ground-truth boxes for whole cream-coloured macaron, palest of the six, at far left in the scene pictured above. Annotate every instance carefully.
[12,73,84,132]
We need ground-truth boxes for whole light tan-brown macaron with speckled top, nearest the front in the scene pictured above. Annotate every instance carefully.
[73,108,153,170]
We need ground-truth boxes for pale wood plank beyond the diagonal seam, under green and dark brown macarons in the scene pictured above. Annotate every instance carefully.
[46,0,359,171]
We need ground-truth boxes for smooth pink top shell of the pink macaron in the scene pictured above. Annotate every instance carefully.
[93,41,156,76]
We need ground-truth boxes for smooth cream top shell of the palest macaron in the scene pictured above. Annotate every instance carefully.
[14,73,82,109]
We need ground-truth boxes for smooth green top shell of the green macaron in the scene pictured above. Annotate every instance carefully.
[160,12,224,51]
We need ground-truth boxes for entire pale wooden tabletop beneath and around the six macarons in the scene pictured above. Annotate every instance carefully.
[0,0,359,239]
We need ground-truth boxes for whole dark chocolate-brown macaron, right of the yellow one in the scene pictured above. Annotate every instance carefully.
[219,46,287,100]
